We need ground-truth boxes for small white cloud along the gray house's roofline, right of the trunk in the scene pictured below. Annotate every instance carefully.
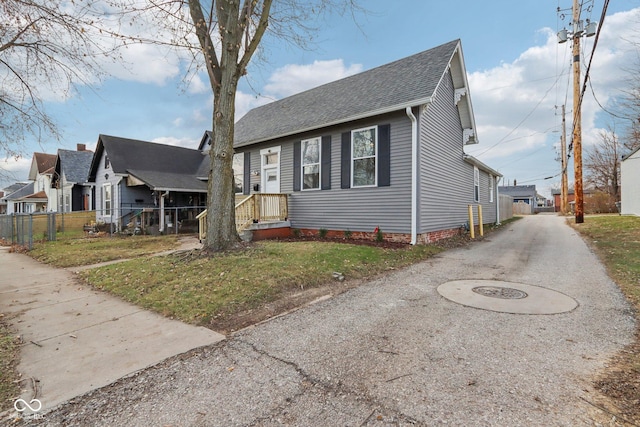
[264,59,362,98]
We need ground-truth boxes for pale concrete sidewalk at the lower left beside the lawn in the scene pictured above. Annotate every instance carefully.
[0,247,224,411]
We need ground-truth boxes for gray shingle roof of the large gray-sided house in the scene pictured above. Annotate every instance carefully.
[234,40,460,147]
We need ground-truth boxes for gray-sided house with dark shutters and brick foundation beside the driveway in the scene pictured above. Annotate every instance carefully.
[220,40,501,243]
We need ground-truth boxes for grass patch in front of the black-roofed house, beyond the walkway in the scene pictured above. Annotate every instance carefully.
[29,235,178,268]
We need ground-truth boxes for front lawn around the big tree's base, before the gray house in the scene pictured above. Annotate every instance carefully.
[82,241,442,325]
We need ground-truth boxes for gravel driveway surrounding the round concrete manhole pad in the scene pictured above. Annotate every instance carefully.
[33,215,635,426]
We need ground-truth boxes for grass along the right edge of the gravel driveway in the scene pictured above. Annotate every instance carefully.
[572,215,640,425]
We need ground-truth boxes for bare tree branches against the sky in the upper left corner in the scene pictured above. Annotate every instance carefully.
[0,0,122,166]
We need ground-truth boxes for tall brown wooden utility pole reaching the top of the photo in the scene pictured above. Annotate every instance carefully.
[573,0,584,224]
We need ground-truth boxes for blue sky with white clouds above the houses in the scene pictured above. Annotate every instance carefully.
[0,0,640,197]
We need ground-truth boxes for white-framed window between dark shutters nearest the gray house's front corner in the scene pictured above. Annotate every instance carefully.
[351,126,378,187]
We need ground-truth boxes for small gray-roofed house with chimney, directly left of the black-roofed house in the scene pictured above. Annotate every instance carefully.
[51,144,95,212]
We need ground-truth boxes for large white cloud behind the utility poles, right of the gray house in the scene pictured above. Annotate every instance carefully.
[466,9,640,166]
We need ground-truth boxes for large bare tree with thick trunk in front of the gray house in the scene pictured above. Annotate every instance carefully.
[133,0,361,251]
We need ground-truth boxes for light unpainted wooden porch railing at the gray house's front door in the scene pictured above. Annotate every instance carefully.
[196,193,289,240]
